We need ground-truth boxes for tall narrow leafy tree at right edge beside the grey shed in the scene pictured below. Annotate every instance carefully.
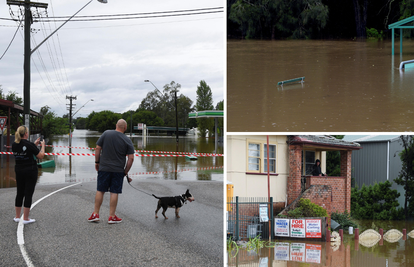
[394,135,414,219]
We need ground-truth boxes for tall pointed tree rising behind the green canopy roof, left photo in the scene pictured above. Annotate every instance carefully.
[195,80,214,137]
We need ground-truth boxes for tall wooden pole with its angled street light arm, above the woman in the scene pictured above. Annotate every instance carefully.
[7,0,108,134]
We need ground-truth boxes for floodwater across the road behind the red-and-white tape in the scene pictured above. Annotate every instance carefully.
[0,130,223,188]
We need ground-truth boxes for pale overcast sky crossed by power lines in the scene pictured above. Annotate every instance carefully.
[0,0,225,117]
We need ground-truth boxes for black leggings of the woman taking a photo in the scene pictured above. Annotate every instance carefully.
[14,165,38,208]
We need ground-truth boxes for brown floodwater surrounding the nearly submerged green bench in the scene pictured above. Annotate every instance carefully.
[227,40,414,132]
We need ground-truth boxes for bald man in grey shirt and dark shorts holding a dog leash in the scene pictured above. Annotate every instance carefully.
[88,119,134,224]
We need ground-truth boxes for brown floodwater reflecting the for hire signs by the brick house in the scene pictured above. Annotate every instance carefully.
[227,221,414,267]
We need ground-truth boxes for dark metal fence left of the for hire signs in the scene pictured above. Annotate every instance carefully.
[226,197,274,241]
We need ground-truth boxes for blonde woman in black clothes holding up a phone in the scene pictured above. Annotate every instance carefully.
[12,126,45,224]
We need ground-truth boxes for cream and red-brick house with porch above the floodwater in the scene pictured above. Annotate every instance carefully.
[227,135,361,217]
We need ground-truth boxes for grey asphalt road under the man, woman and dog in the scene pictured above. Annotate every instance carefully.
[0,180,224,267]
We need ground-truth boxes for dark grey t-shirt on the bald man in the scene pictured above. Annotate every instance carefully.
[96,130,135,172]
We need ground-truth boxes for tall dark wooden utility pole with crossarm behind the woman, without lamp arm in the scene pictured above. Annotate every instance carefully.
[7,0,48,133]
